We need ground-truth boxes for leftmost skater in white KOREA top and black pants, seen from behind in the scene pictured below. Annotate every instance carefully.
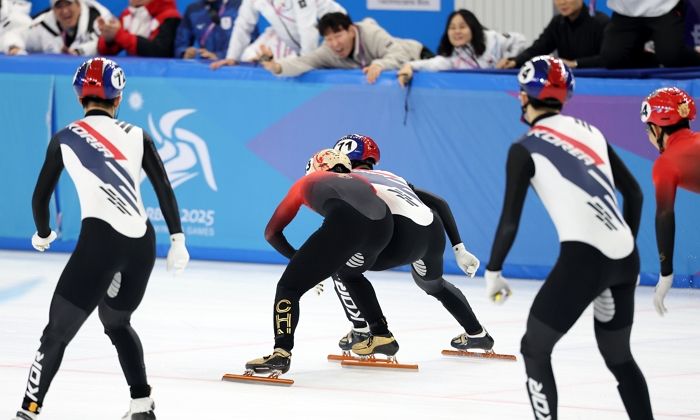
[14,57,189,420]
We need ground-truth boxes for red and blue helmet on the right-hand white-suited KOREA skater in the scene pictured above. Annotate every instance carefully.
[518,55,574,105]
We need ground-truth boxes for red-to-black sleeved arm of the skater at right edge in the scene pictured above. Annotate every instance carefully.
[652,158,678,276]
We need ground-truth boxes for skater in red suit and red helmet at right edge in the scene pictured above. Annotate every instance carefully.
[640,87,700,315]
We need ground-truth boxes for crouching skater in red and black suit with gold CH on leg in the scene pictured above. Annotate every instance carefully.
[246,149,398,374]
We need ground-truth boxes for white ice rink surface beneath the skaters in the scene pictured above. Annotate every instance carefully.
[0,252,700,420]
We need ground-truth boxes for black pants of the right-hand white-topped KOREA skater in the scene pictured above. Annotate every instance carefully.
[521,242,653,420]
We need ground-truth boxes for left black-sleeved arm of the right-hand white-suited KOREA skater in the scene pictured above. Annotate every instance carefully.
[486,143,535,271]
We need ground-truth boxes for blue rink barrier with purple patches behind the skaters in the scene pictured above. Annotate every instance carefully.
[0,56,700,287]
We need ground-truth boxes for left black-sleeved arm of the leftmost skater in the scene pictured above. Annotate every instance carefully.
[32,136,63,238]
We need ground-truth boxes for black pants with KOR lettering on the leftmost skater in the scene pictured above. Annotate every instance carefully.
[22,218,155,412]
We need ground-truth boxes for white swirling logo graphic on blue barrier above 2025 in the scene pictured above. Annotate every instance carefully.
[148,109,217,191]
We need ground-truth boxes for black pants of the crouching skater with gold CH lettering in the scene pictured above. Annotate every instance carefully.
[273,200,394,351]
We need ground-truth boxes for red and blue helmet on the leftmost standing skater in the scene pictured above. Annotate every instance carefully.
[73,57,126,99]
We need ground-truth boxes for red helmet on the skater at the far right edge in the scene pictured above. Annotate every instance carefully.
[639,87,696,127]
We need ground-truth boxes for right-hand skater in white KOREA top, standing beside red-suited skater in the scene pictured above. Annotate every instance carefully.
[485,56,653,420]
